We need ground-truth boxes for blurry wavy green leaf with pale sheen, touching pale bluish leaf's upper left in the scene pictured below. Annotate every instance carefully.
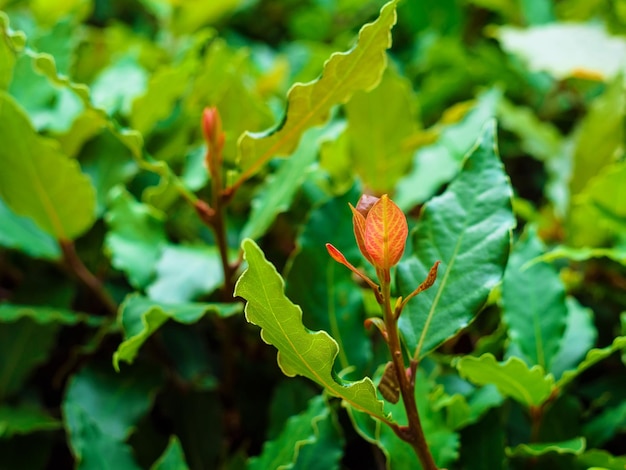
[104,186,167,289]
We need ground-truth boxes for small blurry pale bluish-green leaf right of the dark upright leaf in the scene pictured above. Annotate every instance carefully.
[550,297,598,380]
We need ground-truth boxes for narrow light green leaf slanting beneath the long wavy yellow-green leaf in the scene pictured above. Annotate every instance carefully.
[241,128,325,240]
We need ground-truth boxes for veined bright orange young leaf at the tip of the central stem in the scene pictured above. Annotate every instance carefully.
[365,194,409,269]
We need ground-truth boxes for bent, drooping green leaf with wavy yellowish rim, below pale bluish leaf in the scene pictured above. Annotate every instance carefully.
[113,294,241,370]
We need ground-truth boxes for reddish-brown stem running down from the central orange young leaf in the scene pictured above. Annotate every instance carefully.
[380,271,437,470]
